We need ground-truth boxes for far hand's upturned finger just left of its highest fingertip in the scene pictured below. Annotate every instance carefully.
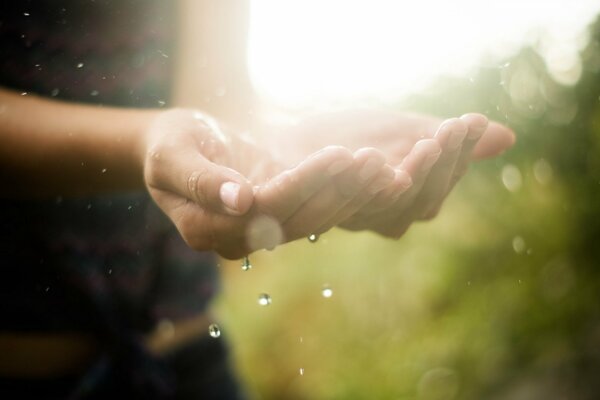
[416,118,469,215]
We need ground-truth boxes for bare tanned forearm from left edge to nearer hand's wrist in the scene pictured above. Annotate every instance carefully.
[0,89,157,197]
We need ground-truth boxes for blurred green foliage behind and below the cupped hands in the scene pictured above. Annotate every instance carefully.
[215,14,600,399]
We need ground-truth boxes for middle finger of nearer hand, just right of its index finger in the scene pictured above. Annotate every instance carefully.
[283,148,393,239]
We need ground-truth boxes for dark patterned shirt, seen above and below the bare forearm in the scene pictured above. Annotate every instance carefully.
[0,0,216,335]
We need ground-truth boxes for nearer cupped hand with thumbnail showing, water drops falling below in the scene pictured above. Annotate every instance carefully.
[142,110,393,258]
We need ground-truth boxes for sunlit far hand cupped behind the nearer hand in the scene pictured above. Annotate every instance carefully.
[270,110,514,238]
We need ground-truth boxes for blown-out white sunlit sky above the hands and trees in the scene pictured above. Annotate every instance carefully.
[249,0,600,107]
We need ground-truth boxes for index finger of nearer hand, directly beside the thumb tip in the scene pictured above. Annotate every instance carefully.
[256,146,353,221]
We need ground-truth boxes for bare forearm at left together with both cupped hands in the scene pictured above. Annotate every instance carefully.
[0,91,514,259]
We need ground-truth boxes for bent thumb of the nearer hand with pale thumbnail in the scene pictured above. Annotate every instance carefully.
[149,150,254,215]
